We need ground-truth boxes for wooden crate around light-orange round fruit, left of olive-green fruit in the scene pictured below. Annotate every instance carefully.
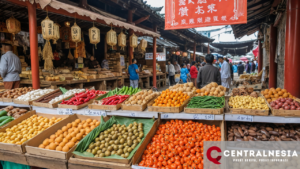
[25,114,100,160]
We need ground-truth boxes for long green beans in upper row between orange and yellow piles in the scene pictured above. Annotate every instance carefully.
[187,96,225,109]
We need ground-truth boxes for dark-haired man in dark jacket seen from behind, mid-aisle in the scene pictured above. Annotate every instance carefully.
[197,54,221,89]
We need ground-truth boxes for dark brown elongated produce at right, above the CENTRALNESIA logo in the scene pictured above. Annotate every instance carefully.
[227,123,300,141]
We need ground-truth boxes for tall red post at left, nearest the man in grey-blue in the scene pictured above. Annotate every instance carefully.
[27,2,40,89]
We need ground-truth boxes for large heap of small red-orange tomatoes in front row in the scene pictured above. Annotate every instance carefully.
[139,120,221,169]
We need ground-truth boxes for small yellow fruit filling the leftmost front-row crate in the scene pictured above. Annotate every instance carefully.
[0,115,62,145]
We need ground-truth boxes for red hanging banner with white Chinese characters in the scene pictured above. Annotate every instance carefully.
[165,0,247,30]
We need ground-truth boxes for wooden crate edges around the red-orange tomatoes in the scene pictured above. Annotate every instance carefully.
[132,120,226,168]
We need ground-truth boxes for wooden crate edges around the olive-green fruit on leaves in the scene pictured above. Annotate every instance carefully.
[69,117,159,169]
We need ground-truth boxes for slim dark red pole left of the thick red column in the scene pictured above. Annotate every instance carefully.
[269,25,277,88]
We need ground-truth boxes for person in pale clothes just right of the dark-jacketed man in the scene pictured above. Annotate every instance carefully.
[219,56,231,90]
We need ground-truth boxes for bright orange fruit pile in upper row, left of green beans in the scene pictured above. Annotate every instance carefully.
[152,89,190,107]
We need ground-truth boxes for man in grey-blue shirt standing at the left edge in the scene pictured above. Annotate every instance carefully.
[0,45,22,89]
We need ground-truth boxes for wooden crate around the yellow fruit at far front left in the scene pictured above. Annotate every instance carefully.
[0,110,69,153]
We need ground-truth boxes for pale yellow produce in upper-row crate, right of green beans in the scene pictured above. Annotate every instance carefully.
[228,96,269,110]
